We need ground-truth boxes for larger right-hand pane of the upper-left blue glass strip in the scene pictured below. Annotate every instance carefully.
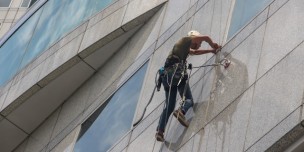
[22,0,113,66]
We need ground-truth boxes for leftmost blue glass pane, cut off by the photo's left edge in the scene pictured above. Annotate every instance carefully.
[0,9,42,86]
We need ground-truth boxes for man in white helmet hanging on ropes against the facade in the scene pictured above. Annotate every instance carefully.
[155,30,221,142]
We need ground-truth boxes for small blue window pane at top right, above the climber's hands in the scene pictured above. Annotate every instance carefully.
[228,0,272,38]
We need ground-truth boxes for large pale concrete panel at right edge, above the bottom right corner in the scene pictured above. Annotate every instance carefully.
[246,40,304,148]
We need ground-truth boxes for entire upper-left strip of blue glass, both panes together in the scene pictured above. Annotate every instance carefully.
[0,0,116,87]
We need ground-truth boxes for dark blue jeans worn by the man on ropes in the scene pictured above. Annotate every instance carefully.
[157,76,193,132]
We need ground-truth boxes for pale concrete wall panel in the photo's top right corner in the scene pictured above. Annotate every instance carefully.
[258,0,304,77]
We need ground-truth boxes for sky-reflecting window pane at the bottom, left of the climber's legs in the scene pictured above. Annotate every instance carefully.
[74,64,147,152]
